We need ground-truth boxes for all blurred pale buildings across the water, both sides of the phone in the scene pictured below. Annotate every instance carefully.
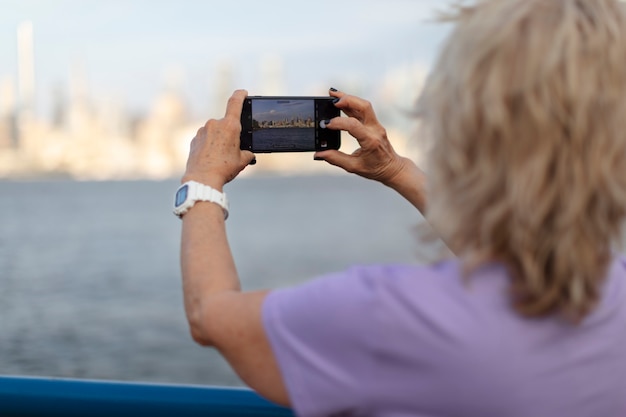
[0,22,423,179]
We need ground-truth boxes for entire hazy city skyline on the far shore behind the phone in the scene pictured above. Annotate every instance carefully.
[0,1,442,179]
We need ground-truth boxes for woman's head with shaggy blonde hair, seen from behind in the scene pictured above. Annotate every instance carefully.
[419,0,626,319]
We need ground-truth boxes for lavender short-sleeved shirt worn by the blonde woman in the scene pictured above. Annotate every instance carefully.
[263,258,626,417]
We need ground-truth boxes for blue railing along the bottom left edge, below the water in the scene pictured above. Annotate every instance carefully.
[0,376,293,417]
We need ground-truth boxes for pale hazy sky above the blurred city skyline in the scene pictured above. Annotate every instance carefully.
[0,0,446,117]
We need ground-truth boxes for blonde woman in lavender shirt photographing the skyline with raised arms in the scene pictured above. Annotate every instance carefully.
[174,0,626,417]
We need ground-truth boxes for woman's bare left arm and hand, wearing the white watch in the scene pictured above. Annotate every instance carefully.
[181,90,289,405]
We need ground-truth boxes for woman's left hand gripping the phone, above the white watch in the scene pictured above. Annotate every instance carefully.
[182,90,254,190]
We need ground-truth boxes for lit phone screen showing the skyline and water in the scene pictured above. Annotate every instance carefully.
[252,99,315,152]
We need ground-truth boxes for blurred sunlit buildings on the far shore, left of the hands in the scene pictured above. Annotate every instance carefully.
[0,22,190,179]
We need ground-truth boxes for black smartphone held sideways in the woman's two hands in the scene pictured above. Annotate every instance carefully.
[241,96,341,153]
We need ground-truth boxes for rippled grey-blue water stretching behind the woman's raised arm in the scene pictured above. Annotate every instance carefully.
[0,175,432,386]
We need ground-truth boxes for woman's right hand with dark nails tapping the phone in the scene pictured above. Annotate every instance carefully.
[315,89,406,185]
